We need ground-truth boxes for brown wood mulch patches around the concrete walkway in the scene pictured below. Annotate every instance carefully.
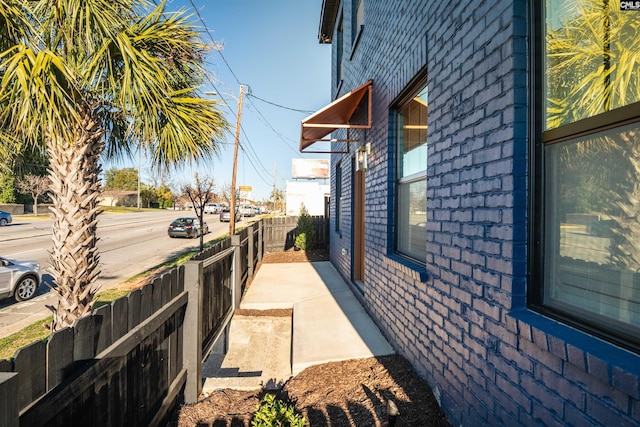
[168,251,450,427]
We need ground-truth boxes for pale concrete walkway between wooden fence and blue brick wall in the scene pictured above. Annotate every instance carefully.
[202,262,393,394]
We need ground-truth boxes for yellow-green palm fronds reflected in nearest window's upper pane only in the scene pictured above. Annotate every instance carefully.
[546,0,640,129]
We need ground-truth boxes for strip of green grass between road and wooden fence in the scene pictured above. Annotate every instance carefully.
[0,234,234,360]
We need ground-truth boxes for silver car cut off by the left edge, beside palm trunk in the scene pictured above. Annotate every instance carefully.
[0,257,42,301]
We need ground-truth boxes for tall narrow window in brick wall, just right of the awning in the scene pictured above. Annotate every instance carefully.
[396,85,427,263]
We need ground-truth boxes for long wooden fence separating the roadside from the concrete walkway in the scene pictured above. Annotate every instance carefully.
[0,218,320,427]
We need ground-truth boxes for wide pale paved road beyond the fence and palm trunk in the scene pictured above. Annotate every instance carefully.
[0,210,252,337]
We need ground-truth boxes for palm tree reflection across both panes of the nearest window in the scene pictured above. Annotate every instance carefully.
[546,0,640,271]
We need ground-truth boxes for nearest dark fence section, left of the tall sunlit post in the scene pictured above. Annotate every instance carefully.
[0,267,188,426]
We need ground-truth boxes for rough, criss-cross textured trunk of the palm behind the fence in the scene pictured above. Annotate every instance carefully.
[47,114,104,331]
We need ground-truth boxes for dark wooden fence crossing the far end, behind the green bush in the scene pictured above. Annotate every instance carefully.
[263,216,329,252]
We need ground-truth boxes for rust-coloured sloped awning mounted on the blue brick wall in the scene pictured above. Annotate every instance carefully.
[300,80,372,153]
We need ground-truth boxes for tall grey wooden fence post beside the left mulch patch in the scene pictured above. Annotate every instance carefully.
[182,261,203,403]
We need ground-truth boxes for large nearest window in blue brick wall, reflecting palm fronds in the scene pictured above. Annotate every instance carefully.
[529,0,640,350]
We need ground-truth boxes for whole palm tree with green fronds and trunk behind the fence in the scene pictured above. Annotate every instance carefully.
[0,0,228,329]
